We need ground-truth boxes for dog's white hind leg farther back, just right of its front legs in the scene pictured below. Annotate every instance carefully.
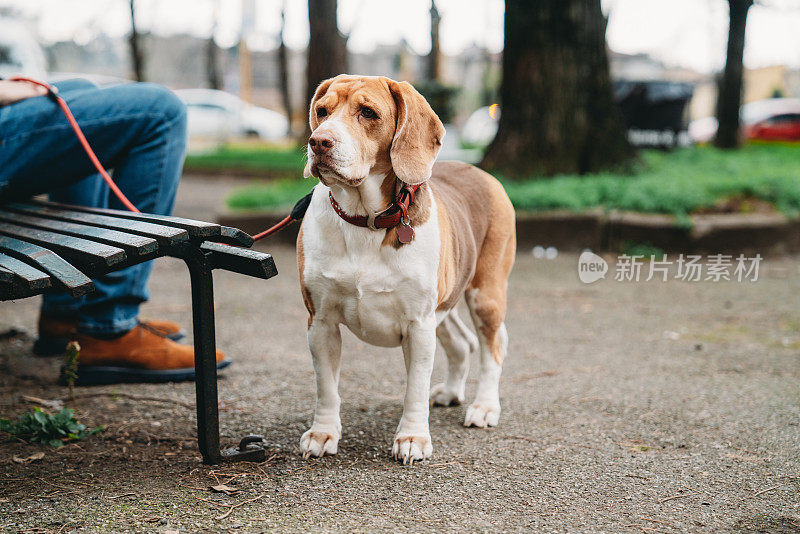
[431,309,478,406]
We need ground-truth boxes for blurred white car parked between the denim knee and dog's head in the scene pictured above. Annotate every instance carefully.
[175,89,289,140]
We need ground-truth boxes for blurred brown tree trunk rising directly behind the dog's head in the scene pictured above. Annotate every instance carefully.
[304,0,347,138]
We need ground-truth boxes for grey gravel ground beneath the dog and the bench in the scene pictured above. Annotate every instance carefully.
[0,179,800,533]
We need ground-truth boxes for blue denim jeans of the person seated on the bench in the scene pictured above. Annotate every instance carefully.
[0,80,186,336]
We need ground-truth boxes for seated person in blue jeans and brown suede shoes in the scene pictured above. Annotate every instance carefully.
[0,80,230,385]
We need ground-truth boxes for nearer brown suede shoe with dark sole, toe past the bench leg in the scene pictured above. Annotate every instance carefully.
[64,325,231,386]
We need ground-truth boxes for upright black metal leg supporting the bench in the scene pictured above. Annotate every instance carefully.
[186,254,222,464]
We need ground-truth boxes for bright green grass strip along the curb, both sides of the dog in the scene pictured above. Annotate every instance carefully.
[222,145,800,219]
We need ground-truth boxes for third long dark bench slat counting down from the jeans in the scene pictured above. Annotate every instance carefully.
[0,209,158,257]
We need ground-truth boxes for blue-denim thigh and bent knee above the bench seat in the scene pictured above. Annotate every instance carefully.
[0,84,186,207]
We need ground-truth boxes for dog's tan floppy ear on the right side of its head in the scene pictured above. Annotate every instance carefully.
[387,80,444,185]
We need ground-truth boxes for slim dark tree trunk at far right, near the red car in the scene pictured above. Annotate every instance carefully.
[714,0,753,148]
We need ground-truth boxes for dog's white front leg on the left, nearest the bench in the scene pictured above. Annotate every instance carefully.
[300,318,342,458]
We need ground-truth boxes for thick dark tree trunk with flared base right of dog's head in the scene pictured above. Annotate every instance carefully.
[481,0,634,177]
